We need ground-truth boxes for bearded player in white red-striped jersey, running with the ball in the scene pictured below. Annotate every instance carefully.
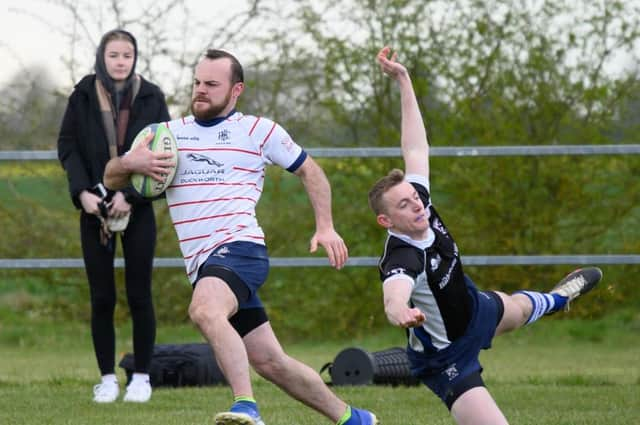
[104,49,378,425]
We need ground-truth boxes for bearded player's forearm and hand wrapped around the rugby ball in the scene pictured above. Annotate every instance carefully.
[103,133,175,190]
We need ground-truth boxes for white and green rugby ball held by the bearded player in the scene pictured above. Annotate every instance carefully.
[131,124,178,198]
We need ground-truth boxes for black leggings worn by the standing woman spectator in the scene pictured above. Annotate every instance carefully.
[80,204,156,375]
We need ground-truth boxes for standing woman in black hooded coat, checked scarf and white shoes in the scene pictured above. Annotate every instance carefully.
[58,29,170,403]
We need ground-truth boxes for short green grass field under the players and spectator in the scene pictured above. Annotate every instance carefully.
[0,313,640,425]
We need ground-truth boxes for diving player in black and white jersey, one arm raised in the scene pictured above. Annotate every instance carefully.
[369,47,602,425]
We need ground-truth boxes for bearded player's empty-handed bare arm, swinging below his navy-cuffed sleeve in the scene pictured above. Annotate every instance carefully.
[295,156,349,269]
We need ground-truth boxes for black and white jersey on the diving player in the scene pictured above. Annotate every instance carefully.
[378,175,473,352]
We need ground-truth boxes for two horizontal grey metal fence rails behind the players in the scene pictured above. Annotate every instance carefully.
[0,144,640,269]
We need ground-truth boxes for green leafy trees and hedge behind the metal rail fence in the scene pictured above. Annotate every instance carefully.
[0,0,640,335]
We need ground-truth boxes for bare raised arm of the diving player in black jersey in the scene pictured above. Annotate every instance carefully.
[377,46,429,178]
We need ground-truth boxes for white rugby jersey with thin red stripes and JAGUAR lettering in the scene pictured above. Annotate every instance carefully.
[166,112,306,283]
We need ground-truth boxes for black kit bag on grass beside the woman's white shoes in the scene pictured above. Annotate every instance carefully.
[119,343,227,388]
